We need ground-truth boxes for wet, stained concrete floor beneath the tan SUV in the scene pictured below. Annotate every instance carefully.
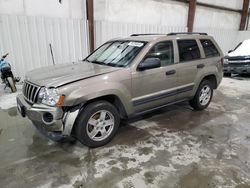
[0,77,250,188]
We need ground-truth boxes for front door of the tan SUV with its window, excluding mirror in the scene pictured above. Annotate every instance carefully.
[132,41,177,112]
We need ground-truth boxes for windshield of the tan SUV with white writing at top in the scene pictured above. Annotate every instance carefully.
[86,41,146,67]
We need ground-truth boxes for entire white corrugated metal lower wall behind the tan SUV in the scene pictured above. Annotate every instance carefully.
[0,15,250,78]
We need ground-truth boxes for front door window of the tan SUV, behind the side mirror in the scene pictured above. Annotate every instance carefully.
[145,41,174,67]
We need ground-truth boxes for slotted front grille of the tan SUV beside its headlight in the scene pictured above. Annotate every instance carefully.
[23,81,40,103]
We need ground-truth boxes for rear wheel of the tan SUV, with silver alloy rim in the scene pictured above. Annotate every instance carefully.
[189,80,213,111]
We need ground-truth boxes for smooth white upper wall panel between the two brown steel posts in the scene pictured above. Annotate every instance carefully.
[94,0,188,26]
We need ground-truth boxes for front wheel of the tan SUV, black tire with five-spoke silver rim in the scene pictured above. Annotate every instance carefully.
[74,101,120,148]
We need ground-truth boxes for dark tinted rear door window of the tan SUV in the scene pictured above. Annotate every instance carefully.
[177,40,201,62]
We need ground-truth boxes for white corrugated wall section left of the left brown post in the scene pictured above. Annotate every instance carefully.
[0,15,88,78]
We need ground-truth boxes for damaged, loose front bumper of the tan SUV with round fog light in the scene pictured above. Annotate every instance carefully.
[17,94,79,137]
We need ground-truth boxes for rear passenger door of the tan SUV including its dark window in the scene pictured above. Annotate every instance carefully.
[176,39,205,100]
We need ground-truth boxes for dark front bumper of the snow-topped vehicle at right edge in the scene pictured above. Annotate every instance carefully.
[223,64,250,74]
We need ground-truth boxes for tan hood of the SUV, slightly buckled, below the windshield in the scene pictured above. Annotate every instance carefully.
[25,62,120,87]
